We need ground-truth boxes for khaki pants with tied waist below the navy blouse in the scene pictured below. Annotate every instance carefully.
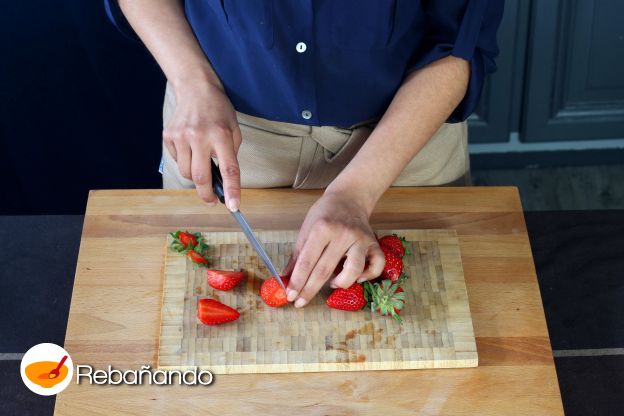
[160,85,470,189]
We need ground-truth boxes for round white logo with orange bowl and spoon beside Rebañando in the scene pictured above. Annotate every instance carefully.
[20,343,74,396]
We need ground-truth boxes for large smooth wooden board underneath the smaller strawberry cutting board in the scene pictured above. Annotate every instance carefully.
[55,187,563,416]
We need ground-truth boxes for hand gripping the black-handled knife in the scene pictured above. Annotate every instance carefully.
[163,81,242,211]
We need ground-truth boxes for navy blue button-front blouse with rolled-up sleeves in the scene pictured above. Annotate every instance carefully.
[104,0,504,127]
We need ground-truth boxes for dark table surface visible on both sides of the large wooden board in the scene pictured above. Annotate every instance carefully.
[0,211,624,416]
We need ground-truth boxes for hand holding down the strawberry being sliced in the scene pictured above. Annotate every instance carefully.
[284,191,386,308]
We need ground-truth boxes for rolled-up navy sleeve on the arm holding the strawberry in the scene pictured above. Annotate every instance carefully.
[409,0,504,123]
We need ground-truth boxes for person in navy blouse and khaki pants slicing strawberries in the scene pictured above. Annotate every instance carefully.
[105,0,503,307]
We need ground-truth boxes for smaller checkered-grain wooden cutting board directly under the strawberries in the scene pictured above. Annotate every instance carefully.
[158,230,478,374]
